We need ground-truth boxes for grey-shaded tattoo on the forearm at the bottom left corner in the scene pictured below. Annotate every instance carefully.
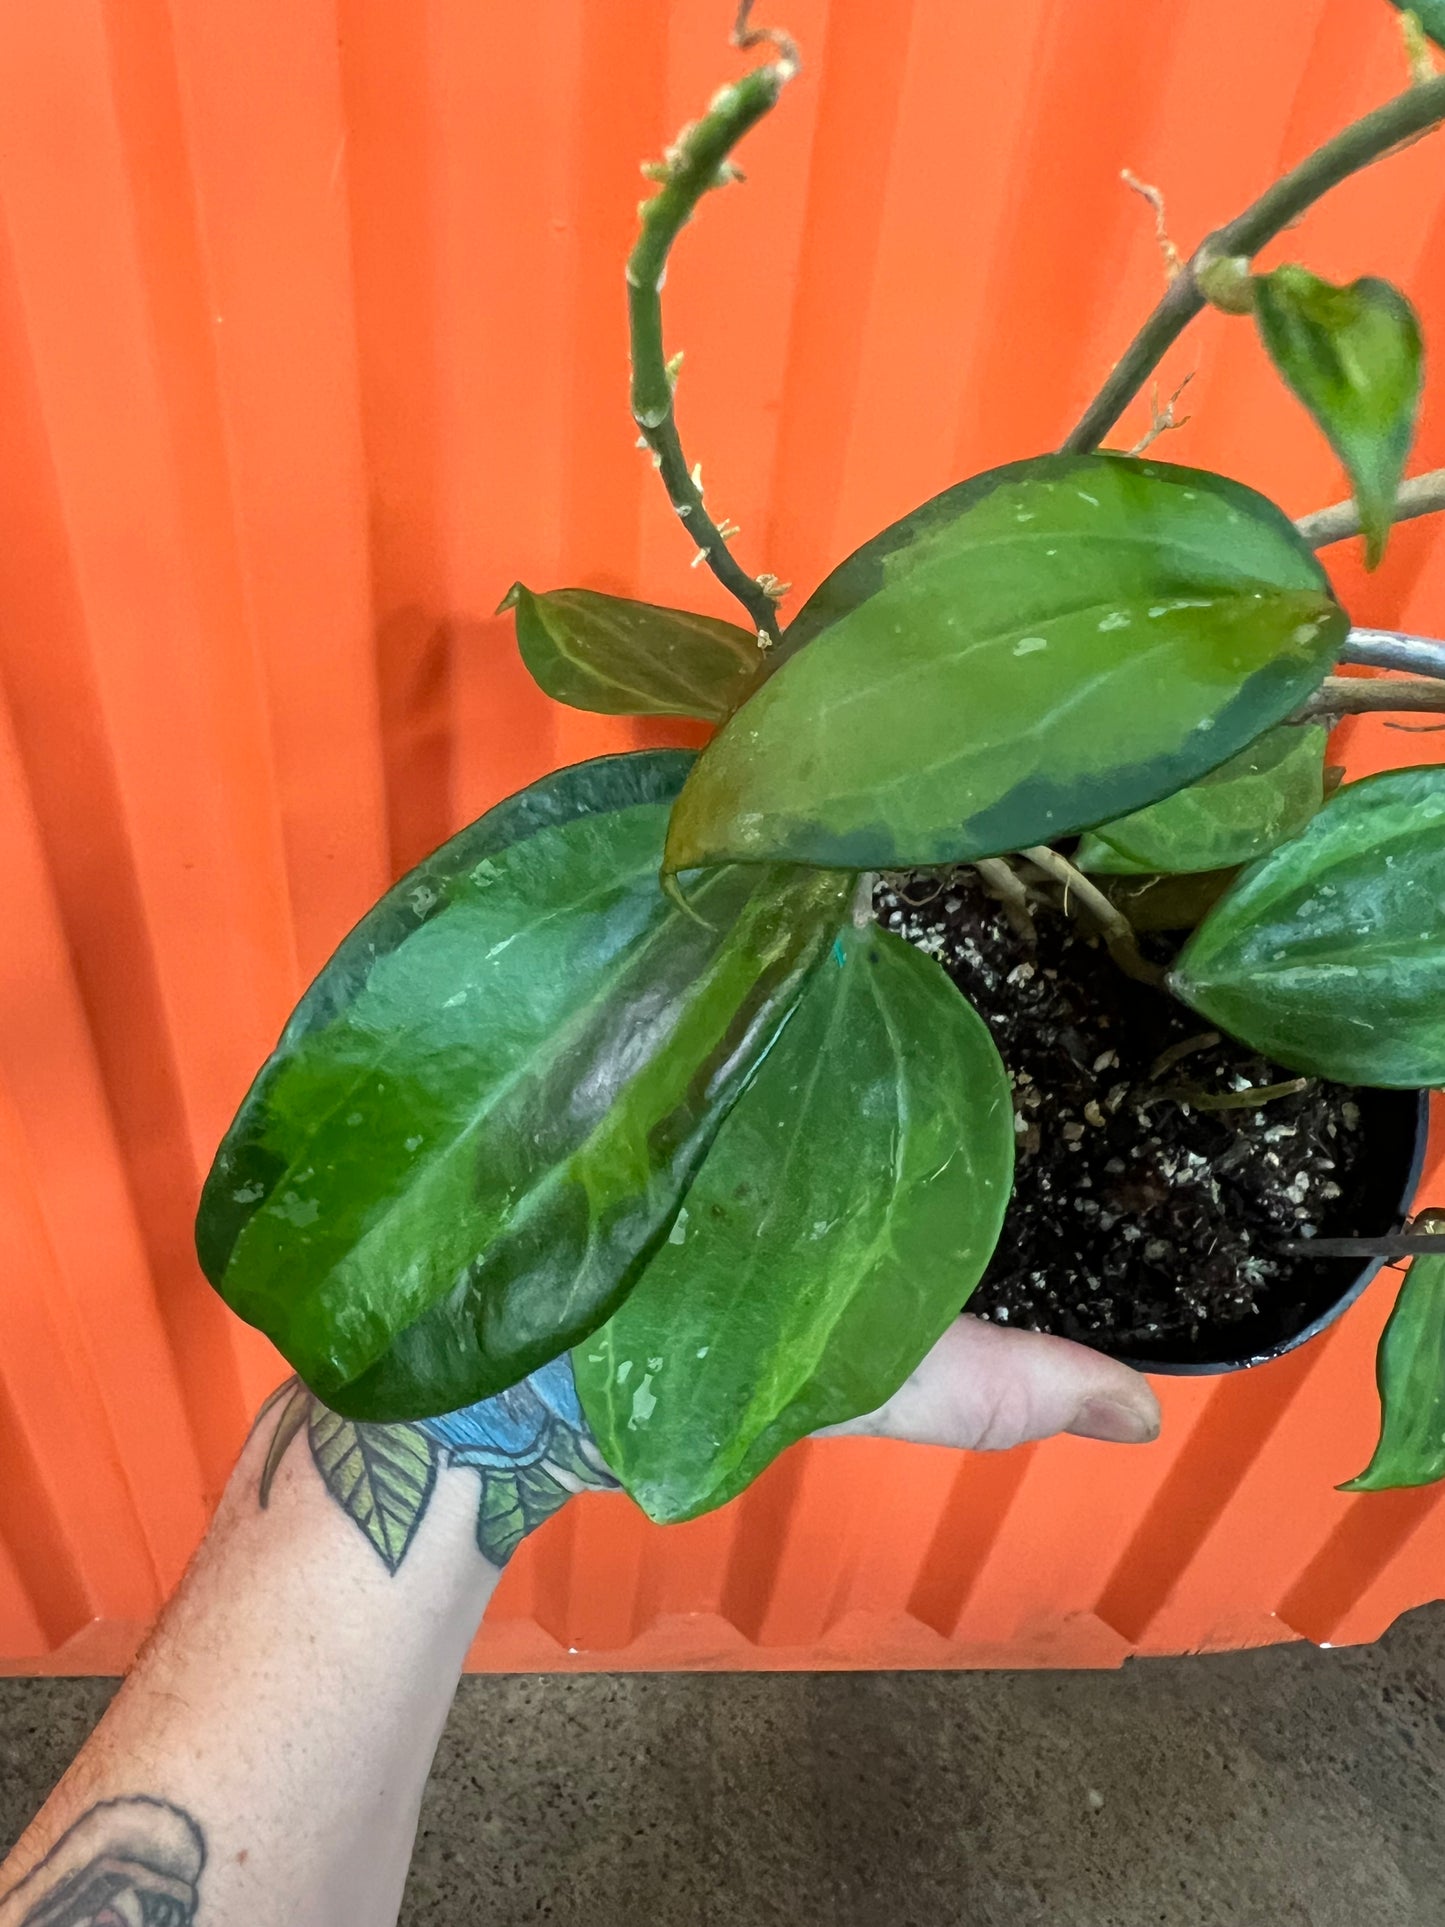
[0,1796,206,1927]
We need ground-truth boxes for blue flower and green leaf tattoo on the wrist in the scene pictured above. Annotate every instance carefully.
[258,1357,617,1564]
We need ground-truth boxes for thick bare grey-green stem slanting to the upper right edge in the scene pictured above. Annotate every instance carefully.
[1064,75,1445,455]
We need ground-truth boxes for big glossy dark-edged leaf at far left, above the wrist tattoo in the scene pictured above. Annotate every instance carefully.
[197,752,848,1420]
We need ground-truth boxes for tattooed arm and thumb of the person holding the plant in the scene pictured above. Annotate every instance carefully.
[0,1318,1158,1927]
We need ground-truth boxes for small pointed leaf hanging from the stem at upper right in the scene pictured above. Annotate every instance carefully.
[1254,266,1424,568]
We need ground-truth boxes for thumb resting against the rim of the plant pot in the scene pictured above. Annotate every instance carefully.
[834,1318,1160,1451]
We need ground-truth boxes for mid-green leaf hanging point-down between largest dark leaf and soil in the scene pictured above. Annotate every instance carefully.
[572,929,1013,1520]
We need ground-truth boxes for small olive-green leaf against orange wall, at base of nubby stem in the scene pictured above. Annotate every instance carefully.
[503,582,763,723]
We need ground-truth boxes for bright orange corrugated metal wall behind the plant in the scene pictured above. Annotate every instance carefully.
[0,0,1445,1669]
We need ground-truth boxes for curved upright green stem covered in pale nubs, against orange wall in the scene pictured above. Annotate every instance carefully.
[626,48,798,646]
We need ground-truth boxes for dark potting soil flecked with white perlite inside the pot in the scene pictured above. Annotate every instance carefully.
[877,869,1418,1364]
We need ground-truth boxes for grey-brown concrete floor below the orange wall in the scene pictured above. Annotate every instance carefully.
[0,1605,1445,1927]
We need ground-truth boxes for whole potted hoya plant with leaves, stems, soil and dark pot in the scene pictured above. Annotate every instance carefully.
[197,0,1445,1553]
